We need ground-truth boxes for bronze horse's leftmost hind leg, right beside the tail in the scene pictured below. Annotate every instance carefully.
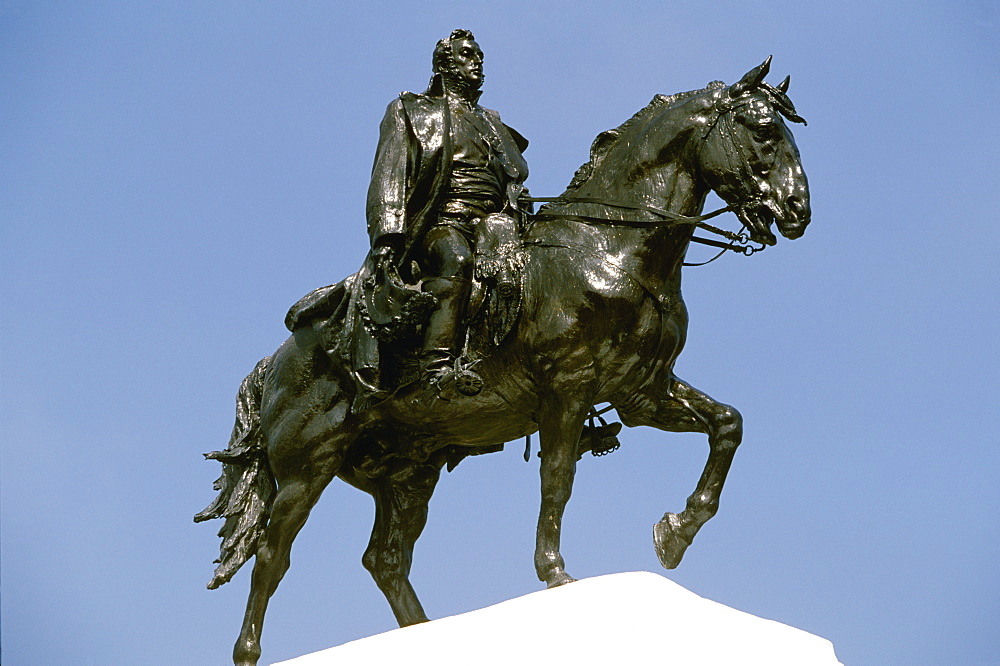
[233,445,342,666]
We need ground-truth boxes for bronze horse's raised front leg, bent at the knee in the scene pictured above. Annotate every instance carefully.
[619,377,743,569]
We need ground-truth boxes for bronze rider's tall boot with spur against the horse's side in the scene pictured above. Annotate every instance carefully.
[420,277,482,396]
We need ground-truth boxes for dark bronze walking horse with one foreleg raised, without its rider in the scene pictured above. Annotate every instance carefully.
[195,58,810,666]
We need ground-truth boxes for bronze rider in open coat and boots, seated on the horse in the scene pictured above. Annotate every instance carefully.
[367,30,528,378]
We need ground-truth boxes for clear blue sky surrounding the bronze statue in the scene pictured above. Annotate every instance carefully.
[0,1,1000,666]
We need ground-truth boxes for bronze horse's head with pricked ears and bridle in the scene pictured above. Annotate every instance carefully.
[699,57,810,245]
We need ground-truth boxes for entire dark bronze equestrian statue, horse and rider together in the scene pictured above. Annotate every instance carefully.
[195,27,810,666]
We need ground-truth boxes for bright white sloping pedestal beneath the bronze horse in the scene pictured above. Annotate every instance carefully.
[275,572,840,666]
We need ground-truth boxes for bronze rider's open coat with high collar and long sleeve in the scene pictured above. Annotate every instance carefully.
[367,75,528,270]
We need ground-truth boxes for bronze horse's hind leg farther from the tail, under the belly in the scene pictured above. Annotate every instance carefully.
[352,462,441,627]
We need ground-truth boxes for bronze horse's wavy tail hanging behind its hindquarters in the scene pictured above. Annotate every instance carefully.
[194,356,275,590]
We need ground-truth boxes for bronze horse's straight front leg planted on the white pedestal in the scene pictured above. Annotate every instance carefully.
[535,392,590,587]
